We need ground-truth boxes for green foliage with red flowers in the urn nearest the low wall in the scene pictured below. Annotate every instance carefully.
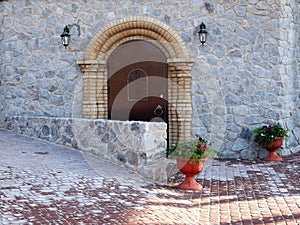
[168,137,217,162]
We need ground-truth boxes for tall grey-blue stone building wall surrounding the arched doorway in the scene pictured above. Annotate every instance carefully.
[0,0,300,161]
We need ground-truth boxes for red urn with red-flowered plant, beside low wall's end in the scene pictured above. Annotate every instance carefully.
[168,137,217,190]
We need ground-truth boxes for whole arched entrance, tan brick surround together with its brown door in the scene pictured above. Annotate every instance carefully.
[77,17,194,145]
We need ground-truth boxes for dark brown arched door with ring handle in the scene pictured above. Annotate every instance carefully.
[108,42,168,122]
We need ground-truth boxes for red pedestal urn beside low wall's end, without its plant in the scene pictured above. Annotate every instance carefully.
[176,158,207,191]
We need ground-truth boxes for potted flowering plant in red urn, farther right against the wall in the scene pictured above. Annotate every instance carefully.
[254,123,288,161]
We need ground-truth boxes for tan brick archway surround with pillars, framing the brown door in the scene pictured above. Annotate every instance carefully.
[77,17,194,144]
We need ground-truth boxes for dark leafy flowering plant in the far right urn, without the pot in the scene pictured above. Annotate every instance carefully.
[254,123,288,144]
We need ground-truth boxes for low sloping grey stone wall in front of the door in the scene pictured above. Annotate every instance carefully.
[2,117,167,182]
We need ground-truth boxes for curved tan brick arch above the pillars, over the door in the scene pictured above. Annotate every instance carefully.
[84,17,189,60]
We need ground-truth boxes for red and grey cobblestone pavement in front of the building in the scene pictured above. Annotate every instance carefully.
[0,130,300,225]
